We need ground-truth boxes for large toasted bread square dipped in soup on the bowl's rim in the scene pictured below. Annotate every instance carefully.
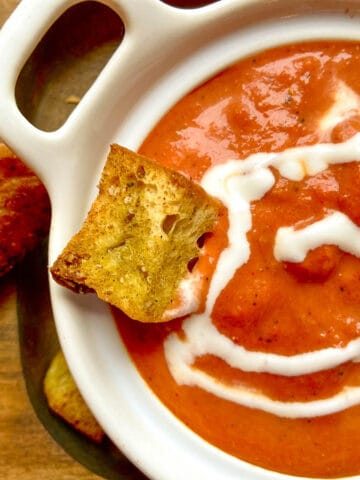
[51,145,220,322]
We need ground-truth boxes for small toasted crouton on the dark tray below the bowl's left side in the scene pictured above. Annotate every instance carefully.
[44,350,105,442]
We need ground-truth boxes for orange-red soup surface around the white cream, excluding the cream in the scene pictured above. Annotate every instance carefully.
[115,42,360,477]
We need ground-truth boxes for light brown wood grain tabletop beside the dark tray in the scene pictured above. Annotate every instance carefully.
[0,0,100,480]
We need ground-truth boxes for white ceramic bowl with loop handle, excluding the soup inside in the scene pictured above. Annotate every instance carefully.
[0,0,360,480]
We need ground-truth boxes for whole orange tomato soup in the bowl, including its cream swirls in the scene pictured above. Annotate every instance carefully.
[115,42,360,478]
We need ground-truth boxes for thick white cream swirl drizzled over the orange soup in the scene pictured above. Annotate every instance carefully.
[164,125,360,418]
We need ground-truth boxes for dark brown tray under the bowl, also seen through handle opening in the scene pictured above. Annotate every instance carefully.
[9,0,214,480]
